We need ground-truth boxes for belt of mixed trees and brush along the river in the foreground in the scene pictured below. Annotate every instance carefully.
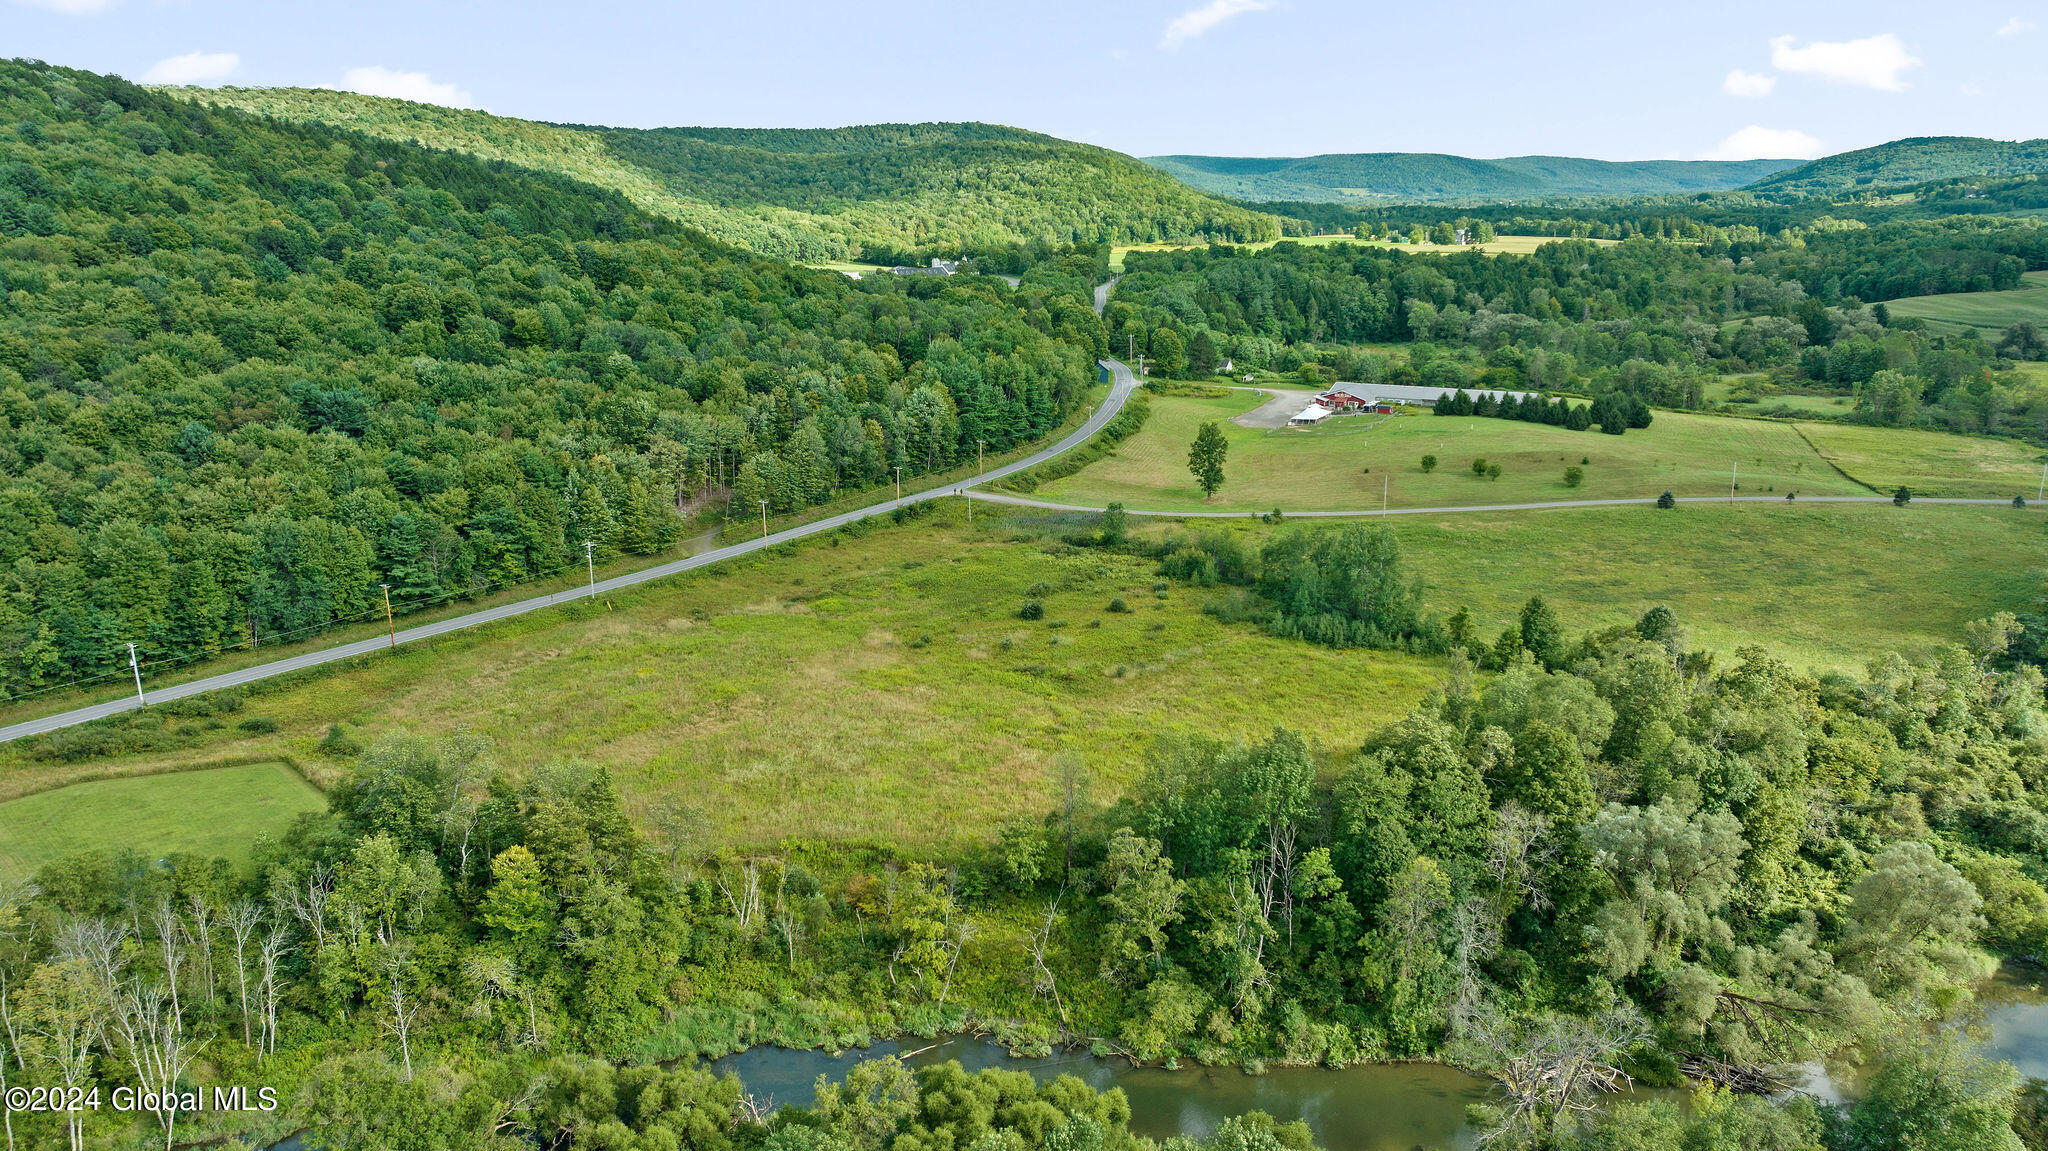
[0,518,2048,1151]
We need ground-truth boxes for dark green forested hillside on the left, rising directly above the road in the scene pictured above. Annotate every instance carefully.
[0,61,1104,694]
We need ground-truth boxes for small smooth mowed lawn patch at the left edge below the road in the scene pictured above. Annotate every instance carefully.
[0,764,328,879]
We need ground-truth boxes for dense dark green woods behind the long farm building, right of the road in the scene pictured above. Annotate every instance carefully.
[1106,219,2048,438]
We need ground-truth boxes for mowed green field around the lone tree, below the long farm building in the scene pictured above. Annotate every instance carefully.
[1036,391,1875,512]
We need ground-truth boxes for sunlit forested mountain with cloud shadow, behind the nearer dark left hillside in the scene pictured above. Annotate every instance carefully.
[174,88,1278,260]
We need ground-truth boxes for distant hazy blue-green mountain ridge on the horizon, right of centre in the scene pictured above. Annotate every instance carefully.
[1145,152,1798,203]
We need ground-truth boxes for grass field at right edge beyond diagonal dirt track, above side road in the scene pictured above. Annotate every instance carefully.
[1798,424,2048,500]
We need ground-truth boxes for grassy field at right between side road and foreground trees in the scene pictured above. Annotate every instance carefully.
[1389,504,2048,670]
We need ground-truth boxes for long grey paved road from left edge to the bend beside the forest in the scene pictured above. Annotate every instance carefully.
[0,360,1139,743]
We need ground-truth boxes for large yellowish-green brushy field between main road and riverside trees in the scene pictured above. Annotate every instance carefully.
[0,516,1438,844]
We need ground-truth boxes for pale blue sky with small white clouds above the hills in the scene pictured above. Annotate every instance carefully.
[0,0,2048,160]
